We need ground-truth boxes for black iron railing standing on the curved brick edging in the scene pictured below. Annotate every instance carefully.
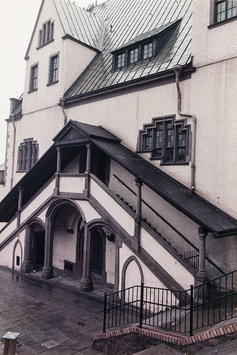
[103,270,237,335]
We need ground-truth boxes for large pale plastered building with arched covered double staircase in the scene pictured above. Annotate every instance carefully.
[0,0,237,291]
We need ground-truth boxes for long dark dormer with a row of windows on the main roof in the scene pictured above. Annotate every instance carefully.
[112,20,180,70]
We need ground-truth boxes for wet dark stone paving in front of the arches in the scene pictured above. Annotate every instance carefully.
[0,267,103,355]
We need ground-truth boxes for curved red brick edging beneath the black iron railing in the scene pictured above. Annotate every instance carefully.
[91,323,237,345]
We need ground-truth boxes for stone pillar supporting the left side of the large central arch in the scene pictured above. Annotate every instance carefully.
[42,217,54,279]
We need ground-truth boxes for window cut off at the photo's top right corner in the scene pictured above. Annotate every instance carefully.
[214,0,237,23]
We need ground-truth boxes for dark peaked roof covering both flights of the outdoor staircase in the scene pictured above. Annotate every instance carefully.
[0,121,237,237]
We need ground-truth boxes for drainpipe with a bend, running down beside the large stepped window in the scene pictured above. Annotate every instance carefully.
[173,64,197,191]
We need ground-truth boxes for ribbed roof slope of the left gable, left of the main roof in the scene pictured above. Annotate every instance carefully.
[54,0,104,51]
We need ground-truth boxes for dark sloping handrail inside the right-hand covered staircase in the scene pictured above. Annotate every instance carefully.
[113,174,224,274]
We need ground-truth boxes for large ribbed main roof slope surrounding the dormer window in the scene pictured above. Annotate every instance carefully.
[65,0,192,101]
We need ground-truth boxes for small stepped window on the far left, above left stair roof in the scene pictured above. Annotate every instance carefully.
[17,138,39,171]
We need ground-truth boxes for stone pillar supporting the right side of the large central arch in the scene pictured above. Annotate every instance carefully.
[80,225,93,292]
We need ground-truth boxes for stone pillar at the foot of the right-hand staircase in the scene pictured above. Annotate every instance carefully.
[195,227,208,299]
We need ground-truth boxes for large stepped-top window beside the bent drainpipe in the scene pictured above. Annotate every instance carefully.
[138,117,189,164]
